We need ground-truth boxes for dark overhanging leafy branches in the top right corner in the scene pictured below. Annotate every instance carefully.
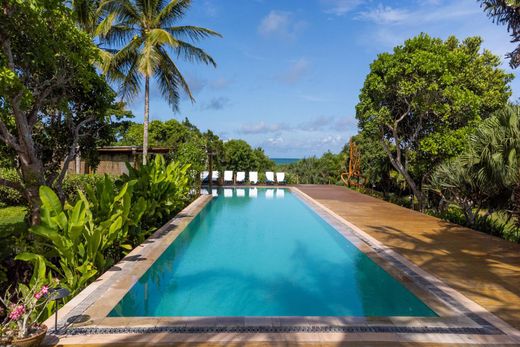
[478,0,520,68]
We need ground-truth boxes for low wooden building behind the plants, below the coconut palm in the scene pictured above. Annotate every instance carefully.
[68,146,171,175]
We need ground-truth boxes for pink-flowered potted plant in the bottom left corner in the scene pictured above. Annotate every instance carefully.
[0,283,51,342]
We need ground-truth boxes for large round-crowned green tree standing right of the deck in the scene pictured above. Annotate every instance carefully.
[356,34,512,209]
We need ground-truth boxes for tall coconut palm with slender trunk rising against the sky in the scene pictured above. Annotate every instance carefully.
[96,0,221,164]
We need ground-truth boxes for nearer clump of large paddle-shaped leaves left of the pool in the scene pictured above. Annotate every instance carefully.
[16,181,138,294]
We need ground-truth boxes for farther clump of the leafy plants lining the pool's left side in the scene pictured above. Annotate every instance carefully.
[120,155,190,245]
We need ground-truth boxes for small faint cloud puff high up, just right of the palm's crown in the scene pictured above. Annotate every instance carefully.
[258,10,306,40]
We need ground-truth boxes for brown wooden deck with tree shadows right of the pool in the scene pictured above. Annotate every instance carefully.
[298,185,520,329]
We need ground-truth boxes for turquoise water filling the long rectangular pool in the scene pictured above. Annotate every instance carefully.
[109,188,436,317]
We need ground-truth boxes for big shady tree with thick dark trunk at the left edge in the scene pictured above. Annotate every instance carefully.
[0,0,116,223]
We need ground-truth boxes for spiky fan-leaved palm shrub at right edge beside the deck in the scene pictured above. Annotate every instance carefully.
[429,106,520,231]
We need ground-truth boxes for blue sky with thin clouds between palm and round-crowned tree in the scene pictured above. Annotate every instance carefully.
[126,0,520,158]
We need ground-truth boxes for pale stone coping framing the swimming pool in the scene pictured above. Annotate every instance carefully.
[42,185,520,345]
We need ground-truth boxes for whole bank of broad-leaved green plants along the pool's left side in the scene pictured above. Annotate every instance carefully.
[15,156,189,300]
